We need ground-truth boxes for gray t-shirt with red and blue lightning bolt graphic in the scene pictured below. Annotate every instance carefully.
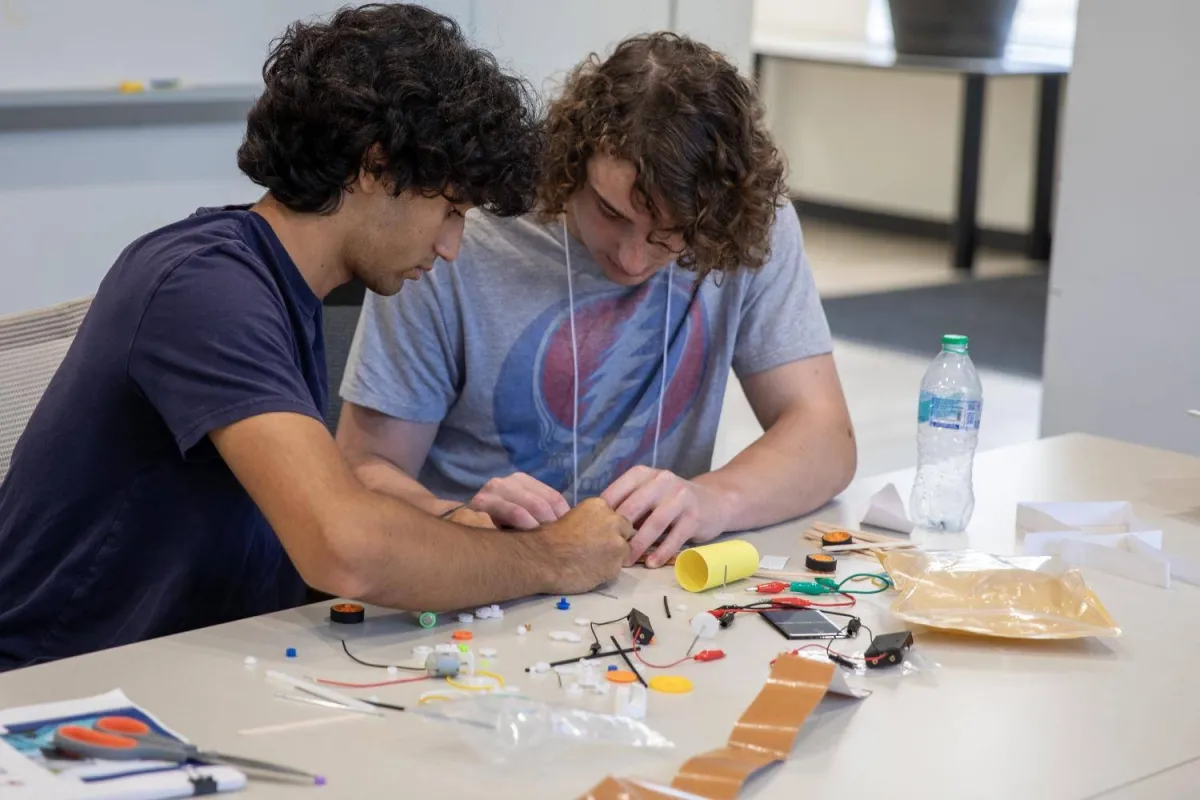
[341,204,833,500]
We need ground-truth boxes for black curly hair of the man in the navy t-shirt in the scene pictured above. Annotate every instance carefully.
[238,4,542,216]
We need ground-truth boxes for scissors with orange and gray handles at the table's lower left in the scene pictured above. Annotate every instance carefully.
[54,716,324,783]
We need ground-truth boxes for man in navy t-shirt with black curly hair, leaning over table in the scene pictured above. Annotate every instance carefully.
[0,5,632,670]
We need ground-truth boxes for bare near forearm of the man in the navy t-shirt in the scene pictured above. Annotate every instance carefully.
[318,484,550,612]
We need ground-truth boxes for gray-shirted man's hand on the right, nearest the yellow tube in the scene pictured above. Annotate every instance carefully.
[600,467,726,567]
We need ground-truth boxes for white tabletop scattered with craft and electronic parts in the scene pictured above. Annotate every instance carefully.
[0,435,1200,800]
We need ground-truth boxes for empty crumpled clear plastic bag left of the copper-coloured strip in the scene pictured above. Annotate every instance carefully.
[409,693,674,762]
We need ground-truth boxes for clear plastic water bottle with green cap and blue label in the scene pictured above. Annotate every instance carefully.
[908,335,983,533]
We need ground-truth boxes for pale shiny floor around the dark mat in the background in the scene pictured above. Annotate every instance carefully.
[713,221,1042,476]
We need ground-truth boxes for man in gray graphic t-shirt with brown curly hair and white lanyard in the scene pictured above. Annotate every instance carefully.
[337,34,856,566]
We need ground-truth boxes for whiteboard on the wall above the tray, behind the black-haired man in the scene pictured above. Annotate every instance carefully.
[0,0,472,90]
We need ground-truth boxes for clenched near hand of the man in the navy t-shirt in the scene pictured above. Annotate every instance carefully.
[540,498,634,595]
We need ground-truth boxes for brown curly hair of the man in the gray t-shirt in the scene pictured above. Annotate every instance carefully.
[538,32,787,276]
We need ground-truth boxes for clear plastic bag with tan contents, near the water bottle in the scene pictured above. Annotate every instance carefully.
[878,551,1121,639]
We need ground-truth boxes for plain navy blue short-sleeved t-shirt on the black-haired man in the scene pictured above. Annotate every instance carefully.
[0,207,328,670]
